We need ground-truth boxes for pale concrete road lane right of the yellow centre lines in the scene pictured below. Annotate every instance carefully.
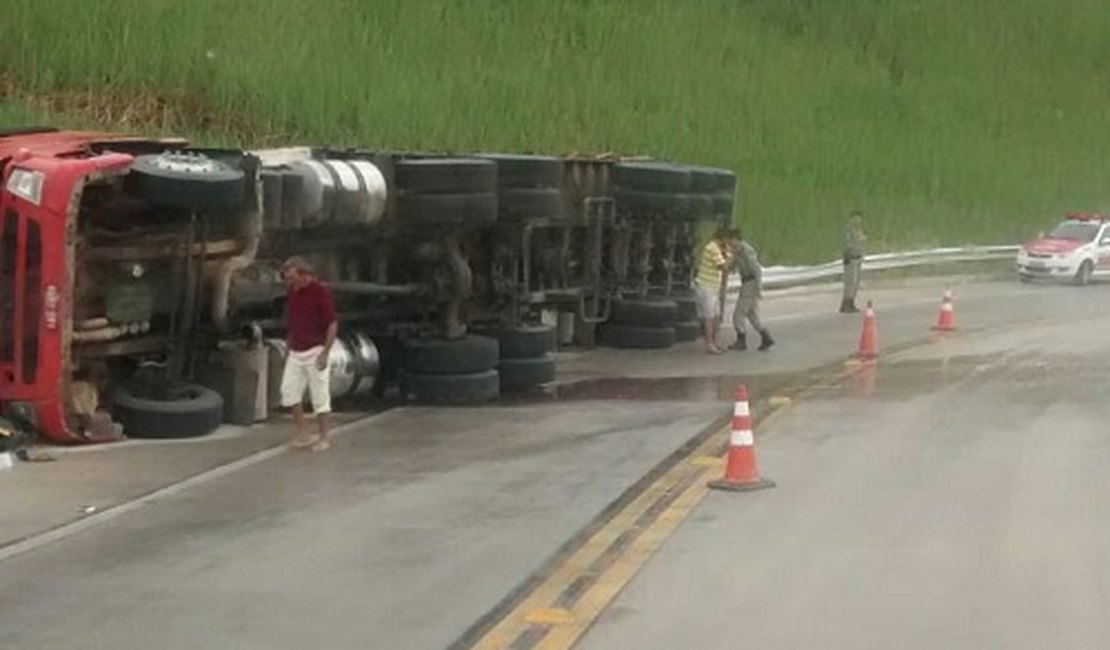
[581,306,1110,650]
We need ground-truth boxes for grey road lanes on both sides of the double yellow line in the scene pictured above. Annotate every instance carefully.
[0,276,1110,650]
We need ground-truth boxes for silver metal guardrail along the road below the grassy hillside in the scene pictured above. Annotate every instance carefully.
[728,246,1020,294]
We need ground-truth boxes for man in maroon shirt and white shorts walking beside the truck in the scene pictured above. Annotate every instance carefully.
[281,257,339,451]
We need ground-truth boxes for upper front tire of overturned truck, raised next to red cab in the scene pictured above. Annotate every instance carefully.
[124,153,246,212]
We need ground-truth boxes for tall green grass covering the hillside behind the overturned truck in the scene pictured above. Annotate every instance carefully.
[0,0,1110,263]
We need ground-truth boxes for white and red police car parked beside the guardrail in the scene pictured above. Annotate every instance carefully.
[1018,212,1110,285]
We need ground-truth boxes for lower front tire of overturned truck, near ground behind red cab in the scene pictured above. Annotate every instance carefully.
[112,384,223,439]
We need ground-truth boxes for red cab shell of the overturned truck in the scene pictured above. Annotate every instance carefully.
[0,131,180,443]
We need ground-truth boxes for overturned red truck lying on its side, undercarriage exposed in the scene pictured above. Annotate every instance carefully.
[0,129,736,444]
